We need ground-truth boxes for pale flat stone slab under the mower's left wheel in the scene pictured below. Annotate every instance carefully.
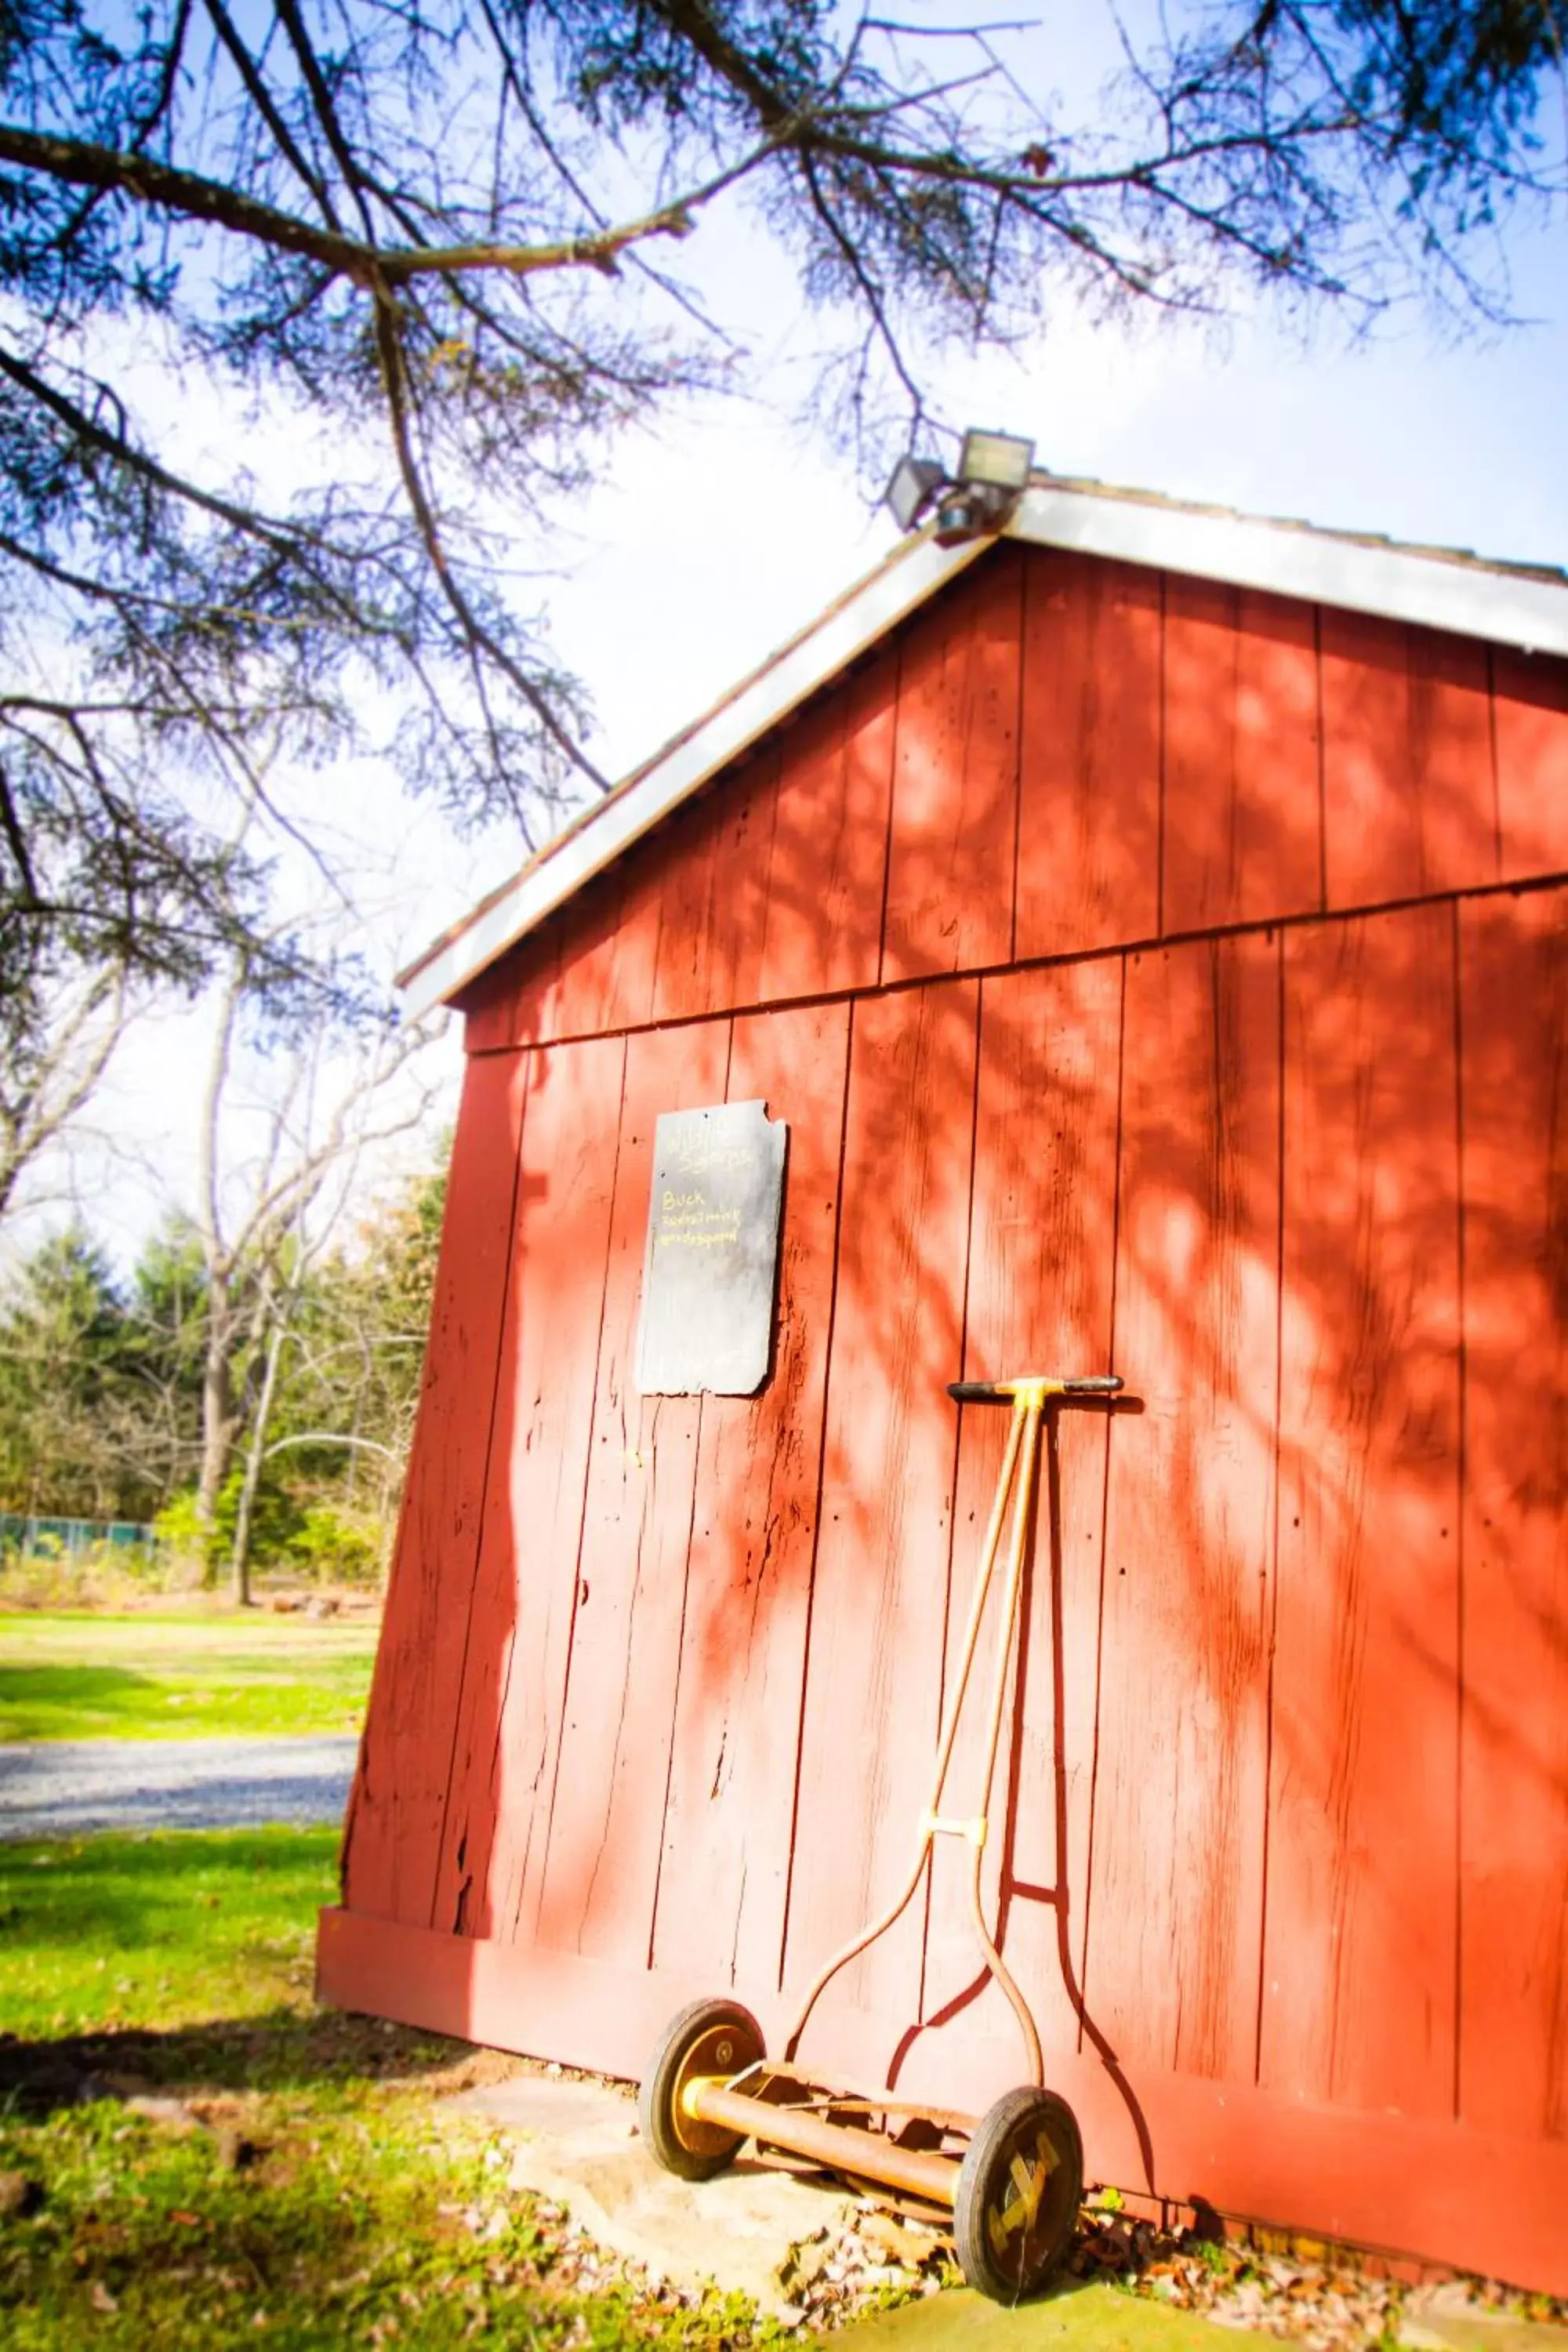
[454,2074,846,2319]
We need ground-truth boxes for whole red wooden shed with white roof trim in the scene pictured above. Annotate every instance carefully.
[320,477,1568,2293]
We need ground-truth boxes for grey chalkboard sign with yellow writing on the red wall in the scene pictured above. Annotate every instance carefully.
[637,1103,787,1397]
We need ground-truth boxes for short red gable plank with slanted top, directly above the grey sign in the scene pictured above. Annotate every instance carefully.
[654,746,779,1021]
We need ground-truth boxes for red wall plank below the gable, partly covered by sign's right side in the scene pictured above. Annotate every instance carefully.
[654,1004,848,1987]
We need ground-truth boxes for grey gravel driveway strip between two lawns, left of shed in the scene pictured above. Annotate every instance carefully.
[0,1733,360,1837]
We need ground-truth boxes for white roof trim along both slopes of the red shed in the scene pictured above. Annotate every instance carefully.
[400,482,1568,1021]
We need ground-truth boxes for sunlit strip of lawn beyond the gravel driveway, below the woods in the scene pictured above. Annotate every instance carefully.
[0,1611,376,1740]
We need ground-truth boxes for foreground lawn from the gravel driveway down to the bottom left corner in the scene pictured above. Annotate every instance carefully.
[0,1830,779,2352]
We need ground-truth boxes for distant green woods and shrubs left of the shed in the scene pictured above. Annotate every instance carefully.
[0,1171,447,1585]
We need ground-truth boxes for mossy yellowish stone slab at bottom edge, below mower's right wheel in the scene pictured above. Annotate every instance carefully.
[841,2279,1236,2352]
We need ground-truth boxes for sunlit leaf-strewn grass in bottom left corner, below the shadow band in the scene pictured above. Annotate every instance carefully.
[0,2082,779,2352]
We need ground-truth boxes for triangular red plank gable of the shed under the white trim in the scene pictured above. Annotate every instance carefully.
[459,541,1568,1051]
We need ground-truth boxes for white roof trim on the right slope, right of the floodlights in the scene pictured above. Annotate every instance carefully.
[1008,482,1568,654]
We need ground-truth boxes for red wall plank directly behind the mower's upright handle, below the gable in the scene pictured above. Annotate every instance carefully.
[924,957,1121,2079]
